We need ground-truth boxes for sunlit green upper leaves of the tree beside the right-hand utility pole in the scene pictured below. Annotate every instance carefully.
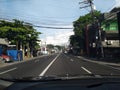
[73,11,100,38]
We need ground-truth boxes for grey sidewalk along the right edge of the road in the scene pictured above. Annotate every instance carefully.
[77,56,120,66]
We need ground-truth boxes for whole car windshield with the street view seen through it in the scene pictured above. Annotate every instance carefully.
[0,0,120,80]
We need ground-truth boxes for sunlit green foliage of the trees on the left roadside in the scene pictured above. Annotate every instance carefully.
[0,19,41,48]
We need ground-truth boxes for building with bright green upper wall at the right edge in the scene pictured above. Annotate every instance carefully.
[102,8,120,57]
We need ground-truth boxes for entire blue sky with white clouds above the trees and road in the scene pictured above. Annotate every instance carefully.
[0,0,120,45]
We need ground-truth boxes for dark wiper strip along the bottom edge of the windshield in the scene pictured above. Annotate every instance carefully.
[0,74,120,82]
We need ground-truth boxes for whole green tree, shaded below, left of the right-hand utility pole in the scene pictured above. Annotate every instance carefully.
[69,11,101,50]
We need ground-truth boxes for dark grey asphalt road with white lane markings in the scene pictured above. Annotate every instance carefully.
[0,53,120,78]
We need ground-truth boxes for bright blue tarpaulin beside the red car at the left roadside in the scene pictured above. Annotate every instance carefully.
[7,50,23,61]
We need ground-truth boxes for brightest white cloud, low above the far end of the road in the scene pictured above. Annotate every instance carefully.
[42,30,74,45]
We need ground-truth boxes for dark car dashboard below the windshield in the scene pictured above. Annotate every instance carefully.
[0,78,120,90]
